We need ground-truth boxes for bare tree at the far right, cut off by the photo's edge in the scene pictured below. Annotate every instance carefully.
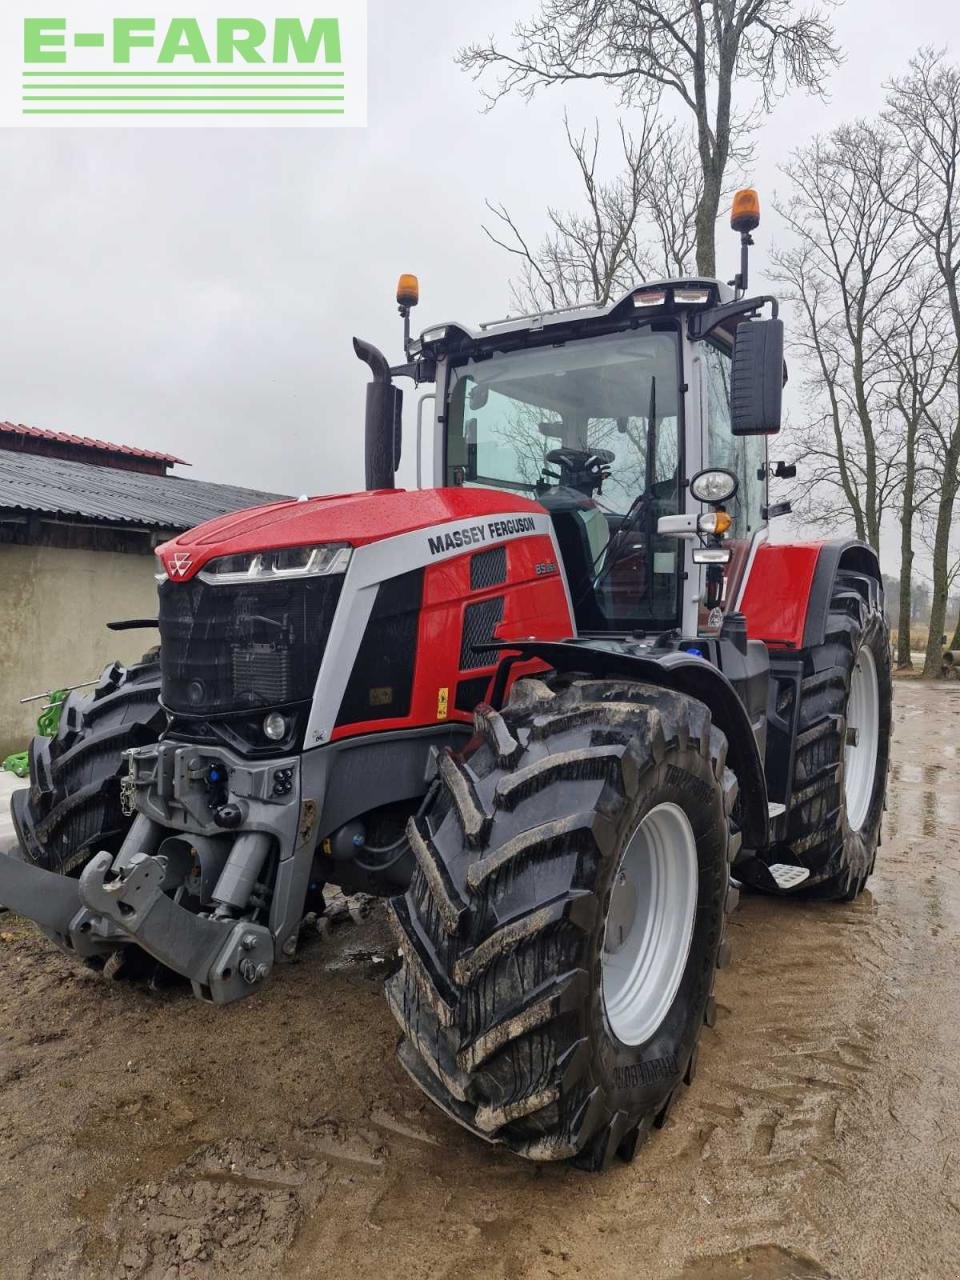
[874,50,960,676]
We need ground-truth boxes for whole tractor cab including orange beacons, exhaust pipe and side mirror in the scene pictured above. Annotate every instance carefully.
[367,193,783,650]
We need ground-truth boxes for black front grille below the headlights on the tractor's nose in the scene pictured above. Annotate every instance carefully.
[160,575,343,716]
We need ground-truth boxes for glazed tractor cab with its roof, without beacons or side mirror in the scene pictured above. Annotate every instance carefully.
[435,293,767,634]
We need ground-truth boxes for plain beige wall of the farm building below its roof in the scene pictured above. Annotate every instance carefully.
[0,544,157,759]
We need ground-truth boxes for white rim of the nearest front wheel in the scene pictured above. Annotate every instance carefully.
[602,804,698,1044]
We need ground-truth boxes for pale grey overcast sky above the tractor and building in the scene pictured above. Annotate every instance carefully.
[0,0,960,568]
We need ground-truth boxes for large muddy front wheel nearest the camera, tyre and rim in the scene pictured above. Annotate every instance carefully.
[387,678,736,1169]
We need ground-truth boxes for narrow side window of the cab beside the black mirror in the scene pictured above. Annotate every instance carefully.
[700,343,767,539]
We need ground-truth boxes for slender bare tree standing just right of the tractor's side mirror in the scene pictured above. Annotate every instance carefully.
[773,124,918,548]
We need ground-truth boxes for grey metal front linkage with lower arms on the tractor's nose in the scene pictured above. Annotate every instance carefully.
[0,741,309,1005]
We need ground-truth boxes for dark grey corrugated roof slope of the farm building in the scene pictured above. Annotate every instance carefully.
[0,449,284,530]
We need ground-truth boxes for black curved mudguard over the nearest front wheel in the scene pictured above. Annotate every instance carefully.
[493,639,769,849]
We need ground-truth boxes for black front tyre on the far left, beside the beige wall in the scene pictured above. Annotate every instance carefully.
[10,649,166,876]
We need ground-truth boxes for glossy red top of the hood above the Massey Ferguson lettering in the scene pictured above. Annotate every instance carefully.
[156,489,543,582]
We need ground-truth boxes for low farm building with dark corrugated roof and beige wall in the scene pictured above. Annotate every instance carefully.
[0,422,284,759]
